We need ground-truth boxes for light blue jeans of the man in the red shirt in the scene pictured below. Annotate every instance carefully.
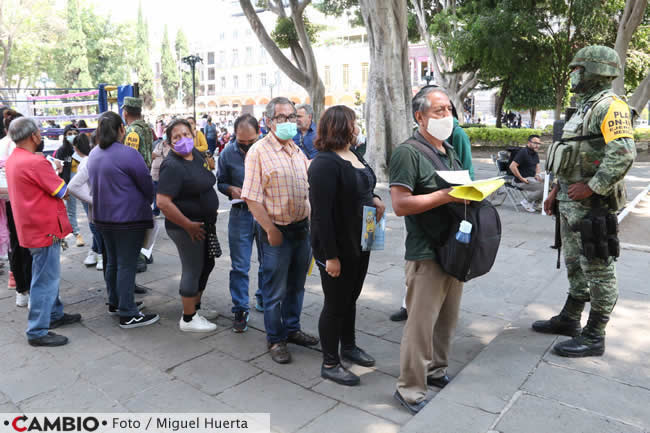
[27,242,63,340]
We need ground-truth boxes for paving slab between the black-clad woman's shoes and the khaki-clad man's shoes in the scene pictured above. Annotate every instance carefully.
[313,369,411,424]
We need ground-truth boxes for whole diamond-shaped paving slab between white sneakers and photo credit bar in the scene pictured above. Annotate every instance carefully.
[170,352,261,395]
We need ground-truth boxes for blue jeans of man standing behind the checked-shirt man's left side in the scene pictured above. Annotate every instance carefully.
[228,207,262,313]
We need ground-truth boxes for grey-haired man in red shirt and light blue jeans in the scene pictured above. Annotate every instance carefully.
[6,117,81,346]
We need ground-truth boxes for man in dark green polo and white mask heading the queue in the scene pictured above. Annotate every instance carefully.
[390,87,463,413]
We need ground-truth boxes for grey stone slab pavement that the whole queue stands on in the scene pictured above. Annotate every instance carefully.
[0,160,650,433]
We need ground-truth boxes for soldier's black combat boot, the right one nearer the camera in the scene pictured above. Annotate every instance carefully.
[553,310,609,358]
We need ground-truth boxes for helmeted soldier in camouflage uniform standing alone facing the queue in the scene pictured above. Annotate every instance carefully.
[533,46,636,357]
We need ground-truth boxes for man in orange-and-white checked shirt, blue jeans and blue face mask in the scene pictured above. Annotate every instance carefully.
[241,97,318,364]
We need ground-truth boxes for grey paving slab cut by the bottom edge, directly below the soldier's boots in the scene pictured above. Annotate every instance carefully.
[495,395,643,433]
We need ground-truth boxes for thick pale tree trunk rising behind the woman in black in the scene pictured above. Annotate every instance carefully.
[359,0,413,181]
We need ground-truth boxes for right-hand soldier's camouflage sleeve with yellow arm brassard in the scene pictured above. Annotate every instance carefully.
[587,97,636,196]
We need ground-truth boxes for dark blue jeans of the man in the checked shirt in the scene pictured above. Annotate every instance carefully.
[257,221,311,344]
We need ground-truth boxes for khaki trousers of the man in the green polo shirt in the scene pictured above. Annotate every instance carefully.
[397,260,463,403]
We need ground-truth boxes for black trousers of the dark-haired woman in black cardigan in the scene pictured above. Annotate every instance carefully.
[318,252,370,365]
